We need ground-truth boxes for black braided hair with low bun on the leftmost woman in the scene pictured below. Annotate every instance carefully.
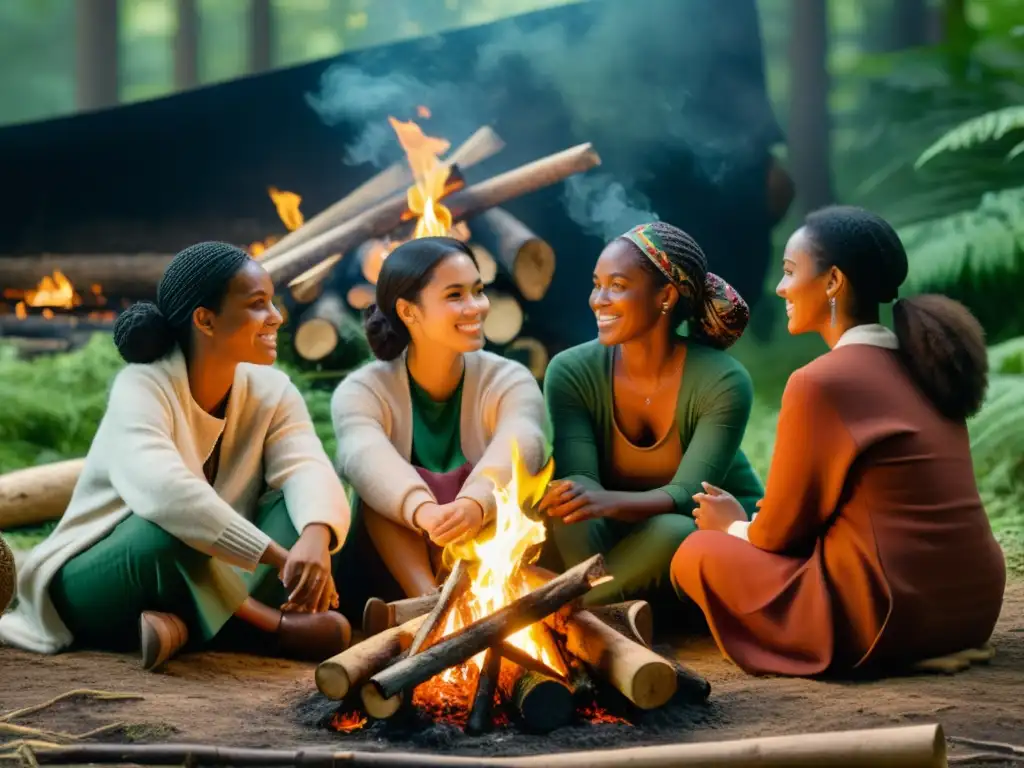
[114,242,249,364]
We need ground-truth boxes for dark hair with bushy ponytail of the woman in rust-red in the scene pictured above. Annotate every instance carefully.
[804,206,988,421]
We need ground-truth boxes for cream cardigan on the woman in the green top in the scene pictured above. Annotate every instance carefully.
[331,351,550,528]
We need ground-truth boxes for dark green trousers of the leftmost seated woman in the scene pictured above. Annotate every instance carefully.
[50,492,301,650]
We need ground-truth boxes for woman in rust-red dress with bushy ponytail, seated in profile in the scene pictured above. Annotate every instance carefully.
[672,207,1006,676]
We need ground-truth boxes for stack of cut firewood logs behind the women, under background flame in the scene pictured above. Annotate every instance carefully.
[259,128,600,378]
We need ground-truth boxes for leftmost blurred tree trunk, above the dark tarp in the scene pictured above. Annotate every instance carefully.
[75,0,119,111]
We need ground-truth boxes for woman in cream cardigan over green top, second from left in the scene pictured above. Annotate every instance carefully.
[331,238,548,597]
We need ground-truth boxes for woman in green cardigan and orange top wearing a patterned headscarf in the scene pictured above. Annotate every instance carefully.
[541,221,763,604]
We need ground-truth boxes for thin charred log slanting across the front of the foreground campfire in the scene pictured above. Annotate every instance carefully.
[370,555,610,697]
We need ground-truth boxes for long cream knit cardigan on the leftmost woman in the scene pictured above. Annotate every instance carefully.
[0,351,350,653]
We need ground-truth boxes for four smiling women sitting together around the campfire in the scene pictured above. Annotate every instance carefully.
[0,207,1006,676]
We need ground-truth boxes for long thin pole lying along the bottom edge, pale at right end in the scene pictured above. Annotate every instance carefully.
[4,724,947,768]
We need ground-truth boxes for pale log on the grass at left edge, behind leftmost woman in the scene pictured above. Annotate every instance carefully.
[0,459,85,530]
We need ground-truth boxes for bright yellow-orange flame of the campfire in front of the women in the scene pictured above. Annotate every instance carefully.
[425,442,568,683]
